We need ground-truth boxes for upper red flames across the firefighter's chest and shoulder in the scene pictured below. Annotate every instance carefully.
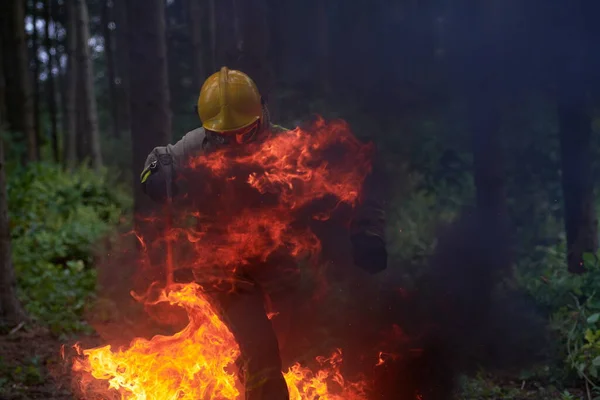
[191,115,372,209]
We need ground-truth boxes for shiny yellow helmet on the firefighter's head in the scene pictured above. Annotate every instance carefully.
[198,67,262,133]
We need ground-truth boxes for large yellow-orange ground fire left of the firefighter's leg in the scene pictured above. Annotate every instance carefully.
[73,284,239,400]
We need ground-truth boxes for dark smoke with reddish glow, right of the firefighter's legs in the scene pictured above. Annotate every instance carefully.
[274,206,548,400]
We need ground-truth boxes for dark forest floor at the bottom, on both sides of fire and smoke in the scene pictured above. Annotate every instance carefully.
[0,328,587,400]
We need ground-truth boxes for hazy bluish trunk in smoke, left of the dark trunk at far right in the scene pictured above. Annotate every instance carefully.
[454,0,510,228]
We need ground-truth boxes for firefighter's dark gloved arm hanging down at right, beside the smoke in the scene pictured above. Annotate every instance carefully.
[350,151,388,274]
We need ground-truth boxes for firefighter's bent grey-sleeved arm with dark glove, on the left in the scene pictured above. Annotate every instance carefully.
[140,128,205,203]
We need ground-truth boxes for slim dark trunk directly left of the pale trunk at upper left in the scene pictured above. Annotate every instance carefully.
[63,1,79,169]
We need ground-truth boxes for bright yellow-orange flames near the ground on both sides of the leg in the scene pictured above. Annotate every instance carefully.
[73,284,366,400]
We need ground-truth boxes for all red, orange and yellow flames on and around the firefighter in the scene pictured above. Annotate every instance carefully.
[73,119,372,400]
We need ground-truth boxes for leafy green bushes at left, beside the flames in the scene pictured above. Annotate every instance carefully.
[8,164,130,332]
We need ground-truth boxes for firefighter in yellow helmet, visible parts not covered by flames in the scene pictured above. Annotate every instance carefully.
[141,67,387,400]
